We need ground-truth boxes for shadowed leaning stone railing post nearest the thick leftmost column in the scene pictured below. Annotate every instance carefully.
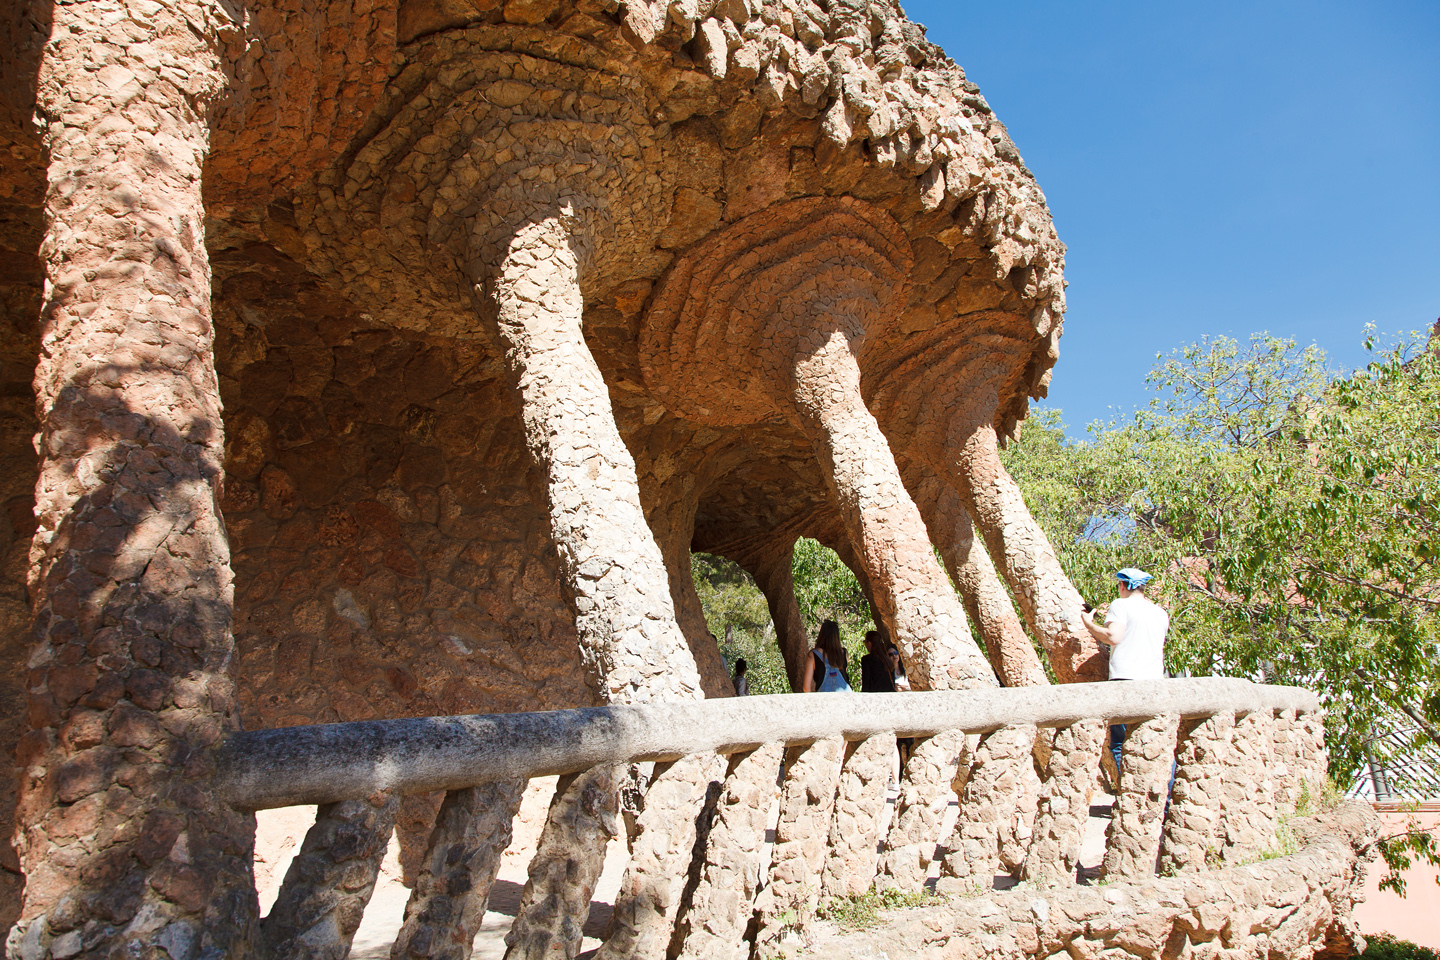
[262,793,400,960]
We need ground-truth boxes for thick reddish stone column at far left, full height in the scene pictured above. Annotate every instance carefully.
[9,0,256,957]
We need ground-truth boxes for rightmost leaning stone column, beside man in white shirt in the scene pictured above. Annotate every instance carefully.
[948,423,1107,684]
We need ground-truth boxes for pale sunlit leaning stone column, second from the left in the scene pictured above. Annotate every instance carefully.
[494,215,703,702]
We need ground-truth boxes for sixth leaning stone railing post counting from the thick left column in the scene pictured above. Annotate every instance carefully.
[755,737,845,957]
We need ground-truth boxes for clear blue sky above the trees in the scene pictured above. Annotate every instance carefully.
[904,0,1440,436]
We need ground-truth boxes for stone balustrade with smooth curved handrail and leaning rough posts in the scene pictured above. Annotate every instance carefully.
[219,678,1325,960]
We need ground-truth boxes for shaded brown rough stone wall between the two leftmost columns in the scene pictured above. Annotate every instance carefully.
[216,248,595,727]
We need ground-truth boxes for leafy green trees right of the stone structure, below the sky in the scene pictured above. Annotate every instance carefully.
[1005,334,1440,892]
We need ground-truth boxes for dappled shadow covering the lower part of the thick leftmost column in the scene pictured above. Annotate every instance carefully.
[7,364,253,949]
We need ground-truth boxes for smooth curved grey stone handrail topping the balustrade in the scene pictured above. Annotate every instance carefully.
[219,678,1319,809]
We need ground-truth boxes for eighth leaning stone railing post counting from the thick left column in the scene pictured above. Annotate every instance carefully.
[876,730,971,892]
